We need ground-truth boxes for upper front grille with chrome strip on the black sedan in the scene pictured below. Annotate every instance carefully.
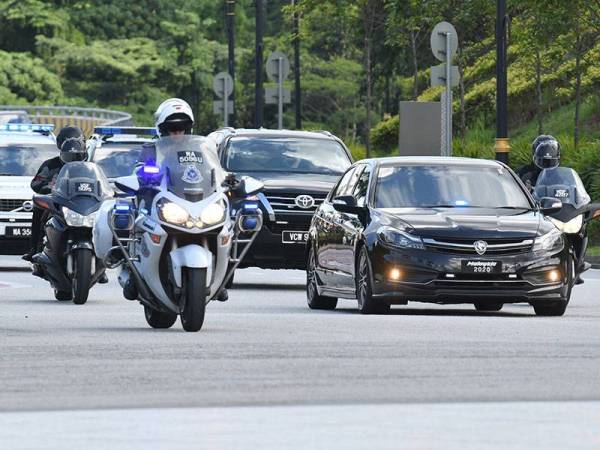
[423,238,533,255]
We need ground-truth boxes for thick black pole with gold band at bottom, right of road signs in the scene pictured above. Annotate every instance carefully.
[496,0,510,164]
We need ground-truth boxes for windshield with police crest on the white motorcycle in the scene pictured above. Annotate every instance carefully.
[156,135,224,201]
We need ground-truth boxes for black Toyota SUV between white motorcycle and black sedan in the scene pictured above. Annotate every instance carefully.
[209,128,352,269]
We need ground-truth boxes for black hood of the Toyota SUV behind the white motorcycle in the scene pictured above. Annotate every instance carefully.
[237,172,340,195]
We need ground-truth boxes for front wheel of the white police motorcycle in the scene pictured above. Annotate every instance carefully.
[181,268,207,331]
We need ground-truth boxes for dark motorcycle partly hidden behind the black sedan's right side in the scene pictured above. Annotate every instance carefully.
[534,167,600,279]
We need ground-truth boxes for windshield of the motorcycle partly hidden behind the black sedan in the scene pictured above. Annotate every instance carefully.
[534,167,591,209]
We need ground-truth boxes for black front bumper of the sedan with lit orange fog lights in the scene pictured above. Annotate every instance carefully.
[371,243,571,304]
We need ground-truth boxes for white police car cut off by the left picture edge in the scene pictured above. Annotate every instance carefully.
[0,123,58,254]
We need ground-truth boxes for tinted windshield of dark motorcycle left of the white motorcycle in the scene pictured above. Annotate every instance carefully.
[52,161,114,212]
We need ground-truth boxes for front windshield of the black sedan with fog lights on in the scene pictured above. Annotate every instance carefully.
[375,164,532,209]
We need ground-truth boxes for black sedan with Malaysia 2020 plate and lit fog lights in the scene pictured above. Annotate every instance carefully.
[307,157,574,316]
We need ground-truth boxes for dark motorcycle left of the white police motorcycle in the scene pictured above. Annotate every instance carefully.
[33,162,114,305]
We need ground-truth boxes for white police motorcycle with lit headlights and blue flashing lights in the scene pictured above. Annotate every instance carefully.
[94,135,262,331]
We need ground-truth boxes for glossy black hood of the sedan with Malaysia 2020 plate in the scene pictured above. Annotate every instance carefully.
[379,208,552,239]
